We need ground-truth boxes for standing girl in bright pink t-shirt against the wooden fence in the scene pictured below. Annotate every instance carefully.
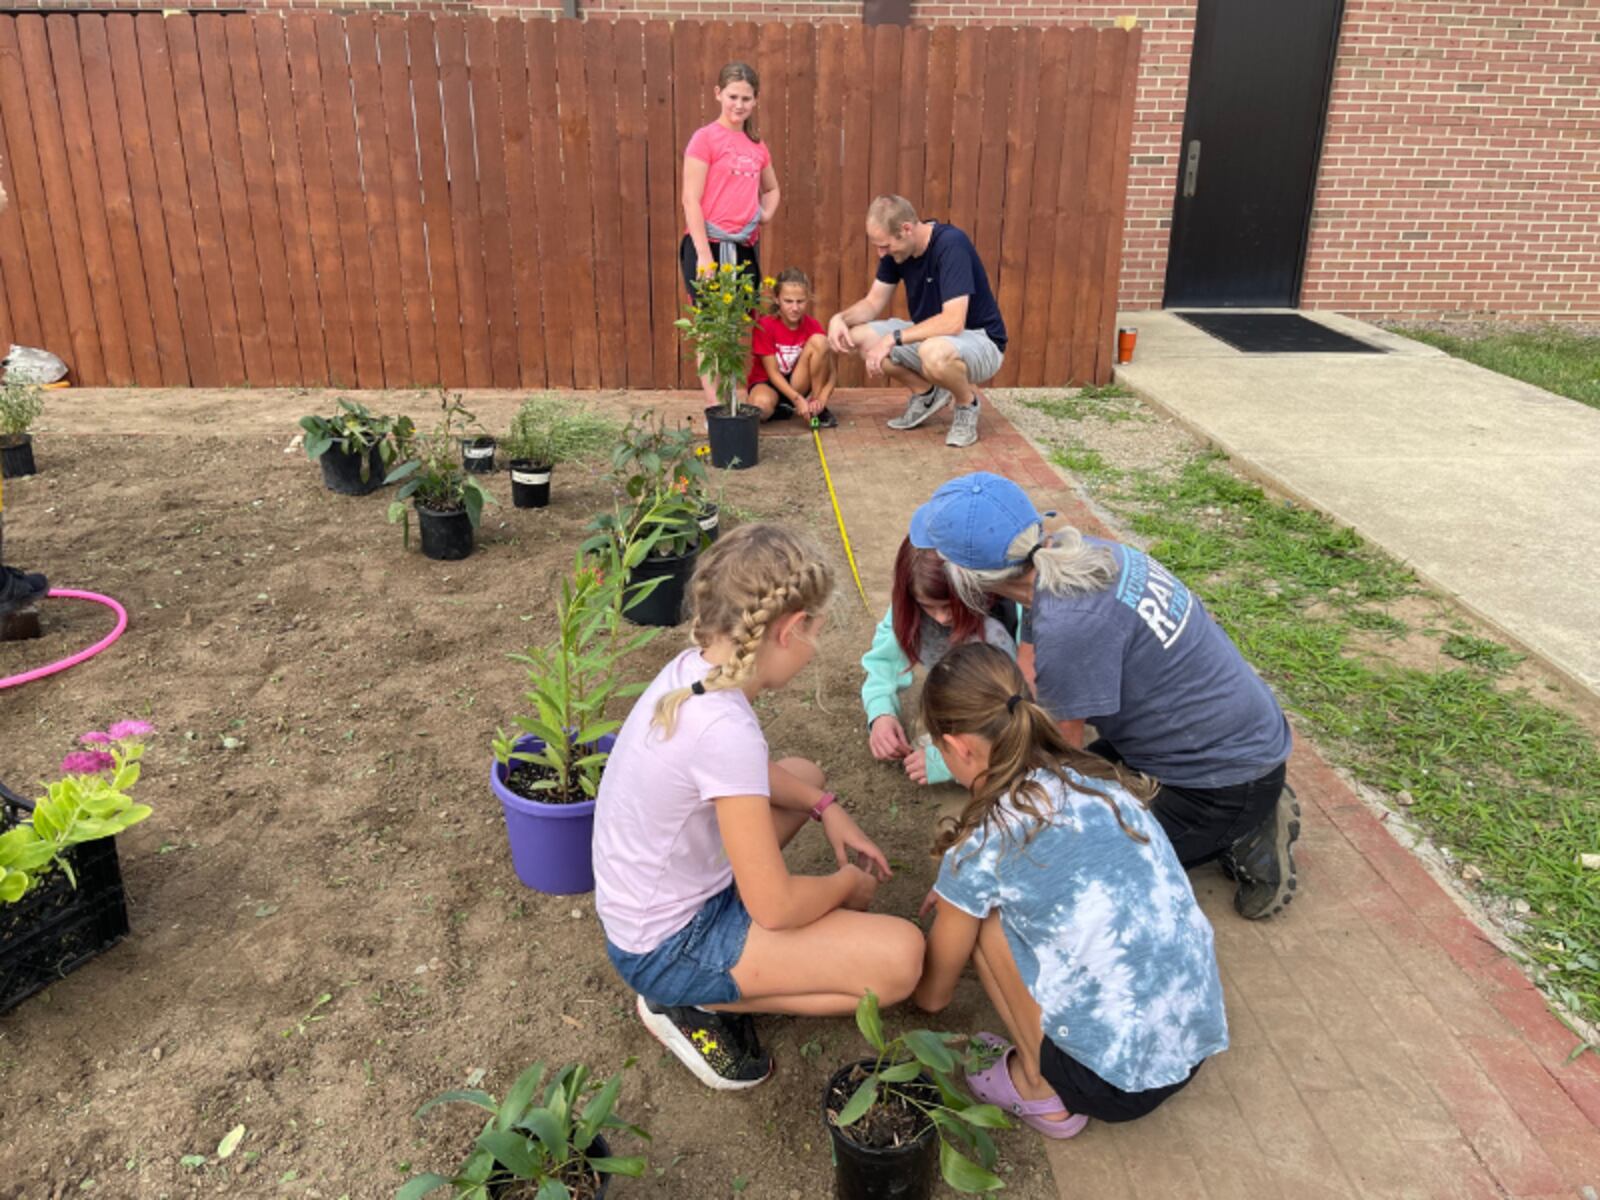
[678,62,778,405]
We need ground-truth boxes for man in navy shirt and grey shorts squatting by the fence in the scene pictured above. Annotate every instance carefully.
[827,195,1006,446]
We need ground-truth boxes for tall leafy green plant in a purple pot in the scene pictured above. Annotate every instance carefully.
[490,499,681,896]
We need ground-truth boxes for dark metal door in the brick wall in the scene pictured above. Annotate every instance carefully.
[1166,0,1344,309]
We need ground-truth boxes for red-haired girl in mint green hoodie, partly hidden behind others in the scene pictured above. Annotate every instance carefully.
[861,538,1016,784]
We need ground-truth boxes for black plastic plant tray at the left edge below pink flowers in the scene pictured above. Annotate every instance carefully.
[0,784,128,1013]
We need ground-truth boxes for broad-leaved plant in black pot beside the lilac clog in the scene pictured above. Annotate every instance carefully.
[822,990,1011,1200]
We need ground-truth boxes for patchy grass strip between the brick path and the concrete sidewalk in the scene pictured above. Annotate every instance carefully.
[1077,450,1600,1021]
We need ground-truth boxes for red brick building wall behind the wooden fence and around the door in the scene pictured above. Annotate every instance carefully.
[11,0,1600,320]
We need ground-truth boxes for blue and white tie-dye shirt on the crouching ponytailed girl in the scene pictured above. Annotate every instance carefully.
[934,771,1227,1091]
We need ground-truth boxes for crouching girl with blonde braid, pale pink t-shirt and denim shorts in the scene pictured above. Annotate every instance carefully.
[594,525,922,1090]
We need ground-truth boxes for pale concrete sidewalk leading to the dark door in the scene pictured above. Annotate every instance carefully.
[1117,312,1600,694]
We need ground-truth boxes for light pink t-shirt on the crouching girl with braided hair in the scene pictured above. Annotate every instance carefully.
[594,650,768,954]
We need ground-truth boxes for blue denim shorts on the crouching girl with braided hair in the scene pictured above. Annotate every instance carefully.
[605,883,750,1006]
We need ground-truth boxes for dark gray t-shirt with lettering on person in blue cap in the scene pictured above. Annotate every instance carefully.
[1030,538,1293,787]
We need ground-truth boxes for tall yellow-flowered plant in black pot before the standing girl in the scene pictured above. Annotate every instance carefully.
[674,262,773,470]
